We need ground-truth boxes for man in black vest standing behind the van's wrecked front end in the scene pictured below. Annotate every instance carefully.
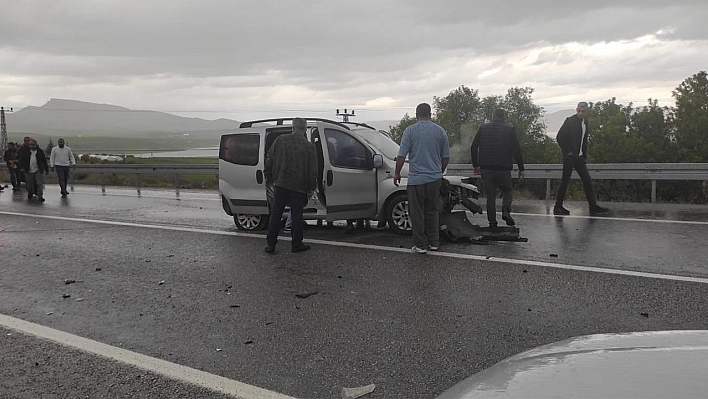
[472,109,524,228]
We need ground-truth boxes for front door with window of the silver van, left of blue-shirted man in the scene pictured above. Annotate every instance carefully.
[317,122,378,221]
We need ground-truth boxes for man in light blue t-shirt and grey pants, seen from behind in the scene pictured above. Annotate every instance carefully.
[393,103,450,254]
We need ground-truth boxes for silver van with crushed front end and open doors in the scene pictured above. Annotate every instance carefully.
[219,118,481,234]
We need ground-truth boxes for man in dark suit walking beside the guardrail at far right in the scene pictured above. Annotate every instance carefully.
[553,101,610,215]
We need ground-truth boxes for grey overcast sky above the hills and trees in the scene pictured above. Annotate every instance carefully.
[0,0,708,121]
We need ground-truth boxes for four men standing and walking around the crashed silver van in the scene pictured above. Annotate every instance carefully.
[265,102,609,254]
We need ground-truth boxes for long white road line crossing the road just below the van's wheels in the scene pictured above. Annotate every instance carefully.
[0,211,708,284]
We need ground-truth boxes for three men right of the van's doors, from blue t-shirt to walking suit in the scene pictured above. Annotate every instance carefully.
[394,102,609,254]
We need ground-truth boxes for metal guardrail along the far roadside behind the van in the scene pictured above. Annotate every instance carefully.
[68,163,708,202]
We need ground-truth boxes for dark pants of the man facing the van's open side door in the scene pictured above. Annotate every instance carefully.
[266,186,307,248]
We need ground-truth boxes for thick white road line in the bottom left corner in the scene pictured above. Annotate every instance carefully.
[0,314,293,399]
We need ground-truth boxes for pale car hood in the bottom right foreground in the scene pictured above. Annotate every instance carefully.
[437,330,708,399]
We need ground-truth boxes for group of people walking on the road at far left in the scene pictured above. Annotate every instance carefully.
[0,137,76,202]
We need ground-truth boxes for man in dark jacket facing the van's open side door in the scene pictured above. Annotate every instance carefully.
[264,118,317,253]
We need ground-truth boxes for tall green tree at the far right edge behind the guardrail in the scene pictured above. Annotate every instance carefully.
[671,71,708,162]
